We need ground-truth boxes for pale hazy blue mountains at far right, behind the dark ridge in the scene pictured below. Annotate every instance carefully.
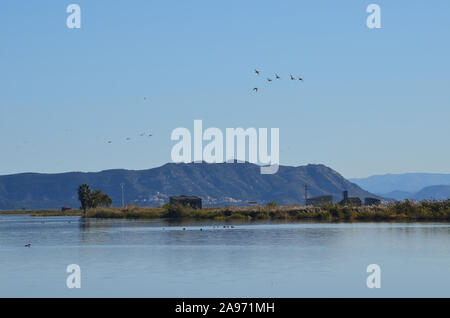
[349,173,450,200]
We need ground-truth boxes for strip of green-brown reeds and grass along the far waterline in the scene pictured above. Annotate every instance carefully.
[0,199,450,222]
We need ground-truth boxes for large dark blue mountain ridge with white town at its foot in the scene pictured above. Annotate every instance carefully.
[0,163,377,210]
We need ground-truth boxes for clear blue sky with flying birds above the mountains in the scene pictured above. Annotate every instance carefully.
[0,0,450,177]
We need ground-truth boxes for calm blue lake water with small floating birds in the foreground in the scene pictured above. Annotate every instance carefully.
[0,215,450,297]
